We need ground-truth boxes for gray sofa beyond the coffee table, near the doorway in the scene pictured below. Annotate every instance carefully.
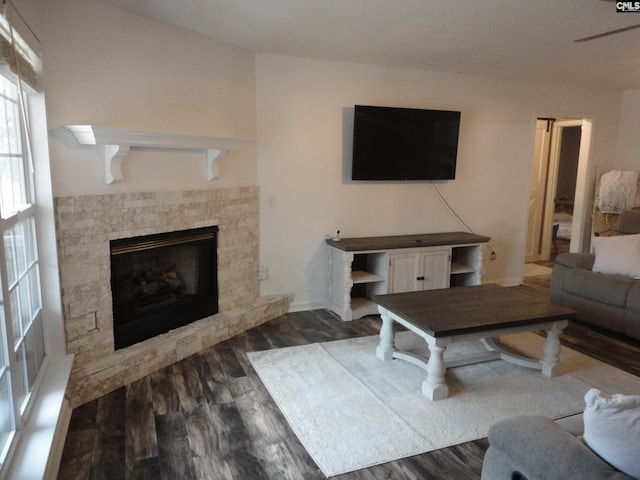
[550,210,640,339]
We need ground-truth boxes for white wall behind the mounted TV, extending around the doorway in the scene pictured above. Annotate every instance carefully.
[256,54,621,309]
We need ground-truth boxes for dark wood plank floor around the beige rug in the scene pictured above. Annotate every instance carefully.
[58,276,640,480]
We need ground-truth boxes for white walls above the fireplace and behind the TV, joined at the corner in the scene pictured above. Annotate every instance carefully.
[41,0,621,316]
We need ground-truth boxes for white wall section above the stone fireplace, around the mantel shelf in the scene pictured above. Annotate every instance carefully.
[42,0,256,196]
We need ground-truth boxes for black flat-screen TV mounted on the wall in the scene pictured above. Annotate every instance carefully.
[351,105,460,181]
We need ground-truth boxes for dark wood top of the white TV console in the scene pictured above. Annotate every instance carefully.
[326,232,491,252]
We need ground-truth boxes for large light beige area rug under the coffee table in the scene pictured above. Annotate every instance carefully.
[247,332,640,477]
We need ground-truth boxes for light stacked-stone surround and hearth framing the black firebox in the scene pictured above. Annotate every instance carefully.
[55,186,291,408]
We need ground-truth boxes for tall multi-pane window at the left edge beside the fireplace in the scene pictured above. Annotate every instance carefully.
[0,9,45,466]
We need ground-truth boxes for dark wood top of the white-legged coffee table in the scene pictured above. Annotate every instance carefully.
[373,284,576,337]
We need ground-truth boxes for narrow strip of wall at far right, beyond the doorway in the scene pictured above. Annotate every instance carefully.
[616,89,640,173]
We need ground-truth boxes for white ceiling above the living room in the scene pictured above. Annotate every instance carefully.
[104,0,640,90]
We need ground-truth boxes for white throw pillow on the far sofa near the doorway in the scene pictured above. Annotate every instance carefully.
[592,234,640,277]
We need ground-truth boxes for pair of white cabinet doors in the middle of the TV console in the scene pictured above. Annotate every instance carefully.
[389,250,450,293]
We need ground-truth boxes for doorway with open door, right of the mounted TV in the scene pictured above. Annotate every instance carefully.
[525,118,592,263]
